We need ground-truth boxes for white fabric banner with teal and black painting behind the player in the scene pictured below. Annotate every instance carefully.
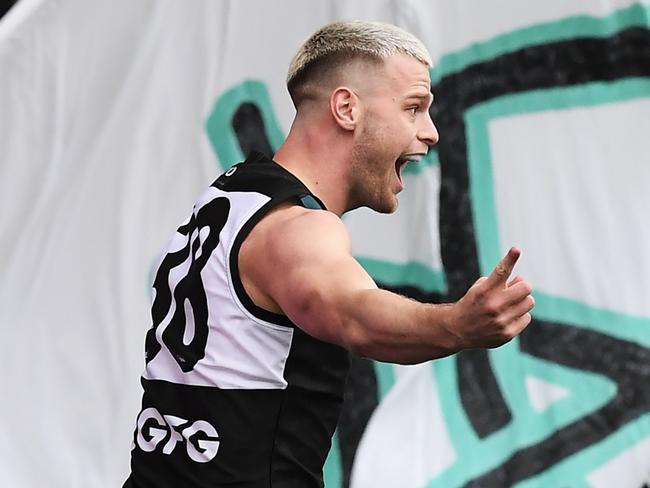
[0,0,650,488]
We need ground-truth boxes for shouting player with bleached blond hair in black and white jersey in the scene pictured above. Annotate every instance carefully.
[125,22,533,488]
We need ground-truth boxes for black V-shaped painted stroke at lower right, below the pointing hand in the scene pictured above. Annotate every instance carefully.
[465,320,650,487]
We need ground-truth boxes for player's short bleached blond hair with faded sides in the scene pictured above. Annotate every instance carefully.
[287,20,432,107]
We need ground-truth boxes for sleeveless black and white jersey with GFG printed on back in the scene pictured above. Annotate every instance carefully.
[124,154,349,488]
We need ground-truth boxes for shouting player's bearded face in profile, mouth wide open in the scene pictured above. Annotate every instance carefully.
[350,54,438,213]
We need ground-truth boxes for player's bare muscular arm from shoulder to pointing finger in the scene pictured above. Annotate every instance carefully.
[240,207,533,363]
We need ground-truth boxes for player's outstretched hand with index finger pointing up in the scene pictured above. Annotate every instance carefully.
[450,247,535,348]
